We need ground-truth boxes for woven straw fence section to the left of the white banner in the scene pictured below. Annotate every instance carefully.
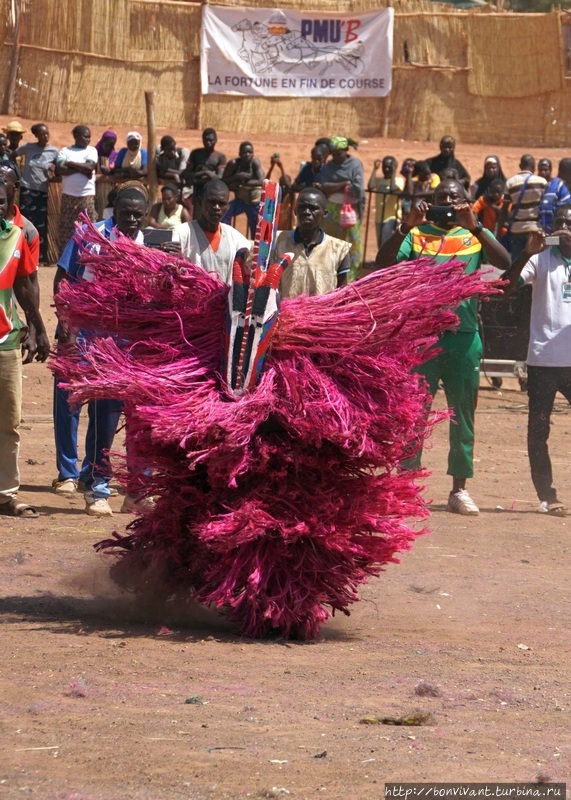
[5,0,201,128]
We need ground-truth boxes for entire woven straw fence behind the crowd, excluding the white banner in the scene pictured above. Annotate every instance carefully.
[0,0,571,146]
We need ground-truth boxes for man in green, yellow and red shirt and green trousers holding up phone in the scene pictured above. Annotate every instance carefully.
[375,180,510,516]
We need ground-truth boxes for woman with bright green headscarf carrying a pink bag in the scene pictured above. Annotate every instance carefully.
[319,136,365,280]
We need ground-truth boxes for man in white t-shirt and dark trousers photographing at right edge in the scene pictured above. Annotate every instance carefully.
[502,205,571,516]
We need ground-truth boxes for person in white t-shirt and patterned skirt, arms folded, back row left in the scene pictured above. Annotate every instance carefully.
[56,125,99,253]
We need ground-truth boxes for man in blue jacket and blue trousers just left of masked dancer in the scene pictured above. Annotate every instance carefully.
[53,186,147,517]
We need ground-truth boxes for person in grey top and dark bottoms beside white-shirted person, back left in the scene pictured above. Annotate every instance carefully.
[14,122,58,264]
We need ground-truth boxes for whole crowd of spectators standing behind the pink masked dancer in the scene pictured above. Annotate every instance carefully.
[0,120,571,516]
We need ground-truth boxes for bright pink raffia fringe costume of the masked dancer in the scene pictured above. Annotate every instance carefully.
[53,222,496,639]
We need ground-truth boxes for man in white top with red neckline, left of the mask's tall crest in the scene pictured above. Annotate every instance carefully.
[170,178,250,286]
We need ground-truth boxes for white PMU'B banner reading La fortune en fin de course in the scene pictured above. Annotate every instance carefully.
[201,5,393,97]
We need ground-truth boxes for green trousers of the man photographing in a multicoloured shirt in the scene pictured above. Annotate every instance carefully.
[409,331,482,478]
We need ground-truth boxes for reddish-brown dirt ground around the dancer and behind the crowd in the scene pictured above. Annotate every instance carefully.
[0,120,571,800]
